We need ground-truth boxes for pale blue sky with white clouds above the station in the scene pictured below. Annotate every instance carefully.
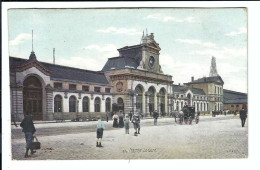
[8,8,247,93]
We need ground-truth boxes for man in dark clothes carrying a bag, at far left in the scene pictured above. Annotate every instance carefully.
[20,112,36,158]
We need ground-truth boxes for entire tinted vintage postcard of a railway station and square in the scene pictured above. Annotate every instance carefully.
[6,8,249,160]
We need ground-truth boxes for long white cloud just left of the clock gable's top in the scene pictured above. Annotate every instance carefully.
[97,27,142,35]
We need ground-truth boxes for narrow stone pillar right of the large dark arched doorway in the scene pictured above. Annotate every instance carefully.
[43,84,54,120]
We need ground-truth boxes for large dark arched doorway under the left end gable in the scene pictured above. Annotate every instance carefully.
[23,76,43,120]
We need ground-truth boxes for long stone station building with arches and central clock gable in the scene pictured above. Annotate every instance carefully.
[9,33,246,121]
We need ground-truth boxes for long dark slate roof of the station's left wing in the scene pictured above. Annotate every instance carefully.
[9,57,109,85]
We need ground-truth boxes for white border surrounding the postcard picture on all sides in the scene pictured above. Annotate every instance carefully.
[2,1,260,170]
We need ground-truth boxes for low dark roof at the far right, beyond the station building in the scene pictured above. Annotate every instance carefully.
[223,89,247,104]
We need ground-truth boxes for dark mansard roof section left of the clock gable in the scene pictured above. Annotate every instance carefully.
[102,56,139,71]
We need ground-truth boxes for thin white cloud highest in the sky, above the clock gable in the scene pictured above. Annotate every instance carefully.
[145,14,196,23]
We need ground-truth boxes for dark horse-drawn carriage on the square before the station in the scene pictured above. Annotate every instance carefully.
[171,106,199,125]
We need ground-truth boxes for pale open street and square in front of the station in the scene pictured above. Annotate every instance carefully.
[12,115,248,160]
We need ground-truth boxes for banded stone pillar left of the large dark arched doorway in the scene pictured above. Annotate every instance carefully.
[10,85,24,122]
